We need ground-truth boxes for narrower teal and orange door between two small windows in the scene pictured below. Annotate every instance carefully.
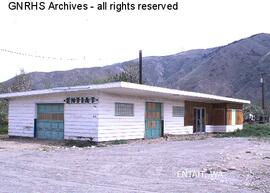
[145,102,162,139]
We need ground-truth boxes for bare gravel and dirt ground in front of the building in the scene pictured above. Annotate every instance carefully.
[0,138,270,193]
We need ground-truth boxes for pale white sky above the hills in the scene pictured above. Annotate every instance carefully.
[0,0,270,82]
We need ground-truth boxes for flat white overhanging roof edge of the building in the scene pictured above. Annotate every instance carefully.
[0,82,250,104]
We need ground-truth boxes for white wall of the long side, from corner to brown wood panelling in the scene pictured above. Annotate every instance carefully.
[98,93,193,141]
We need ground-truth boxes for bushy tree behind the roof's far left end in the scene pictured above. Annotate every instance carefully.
[9,69,32,92]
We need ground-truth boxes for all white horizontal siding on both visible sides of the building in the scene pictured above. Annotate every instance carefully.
[9,89,245,141]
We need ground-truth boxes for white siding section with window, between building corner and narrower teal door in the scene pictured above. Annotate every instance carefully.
[98,94,145,141]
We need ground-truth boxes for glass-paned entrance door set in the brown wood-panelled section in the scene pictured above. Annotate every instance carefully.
[194,108,205,133]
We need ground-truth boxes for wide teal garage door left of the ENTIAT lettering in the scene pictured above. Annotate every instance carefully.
[36,104,64,140]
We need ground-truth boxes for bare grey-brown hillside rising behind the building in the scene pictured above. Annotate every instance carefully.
[0,34,270,103]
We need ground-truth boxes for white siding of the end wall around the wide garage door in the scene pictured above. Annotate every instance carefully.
[9,93,98,140]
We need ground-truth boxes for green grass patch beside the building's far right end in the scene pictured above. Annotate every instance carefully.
[222,124,270,138]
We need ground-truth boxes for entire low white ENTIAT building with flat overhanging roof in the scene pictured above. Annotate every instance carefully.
[0,82,250,142]
